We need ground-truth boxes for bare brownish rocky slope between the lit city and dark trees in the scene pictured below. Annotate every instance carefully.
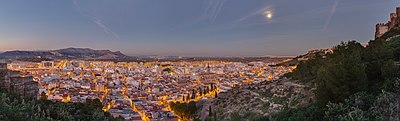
[202,80,314,120]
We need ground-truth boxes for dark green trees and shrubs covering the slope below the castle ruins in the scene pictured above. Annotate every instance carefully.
[272,30,400,121]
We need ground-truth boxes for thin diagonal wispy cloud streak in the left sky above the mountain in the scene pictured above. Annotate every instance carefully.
[72,0,119,39]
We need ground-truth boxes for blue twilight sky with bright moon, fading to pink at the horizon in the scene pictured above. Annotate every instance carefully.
[0,0,400,56]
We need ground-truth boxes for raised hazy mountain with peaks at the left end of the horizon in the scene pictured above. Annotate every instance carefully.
[0,48,131,59]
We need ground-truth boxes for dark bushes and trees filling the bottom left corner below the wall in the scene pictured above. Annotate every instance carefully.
[0,89,123,121]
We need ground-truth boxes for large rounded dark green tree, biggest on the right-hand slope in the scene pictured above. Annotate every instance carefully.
[316,41,368,105]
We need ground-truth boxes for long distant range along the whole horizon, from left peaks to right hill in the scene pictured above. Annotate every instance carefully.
[0,48,291,63]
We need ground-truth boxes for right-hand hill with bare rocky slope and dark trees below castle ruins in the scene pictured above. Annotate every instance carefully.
[198,20,400,121]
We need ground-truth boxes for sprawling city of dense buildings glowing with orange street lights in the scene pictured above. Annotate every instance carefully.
[2,60,295,121]
